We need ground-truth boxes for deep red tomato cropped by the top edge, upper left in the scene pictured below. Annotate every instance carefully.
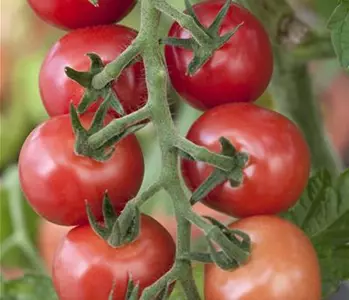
[28,0,136,30]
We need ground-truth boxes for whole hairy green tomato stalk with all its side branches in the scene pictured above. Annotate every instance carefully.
[89,0,249,300]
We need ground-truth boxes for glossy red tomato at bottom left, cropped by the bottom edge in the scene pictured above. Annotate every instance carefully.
[53,215,176,300]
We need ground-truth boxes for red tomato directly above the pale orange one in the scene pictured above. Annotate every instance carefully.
[182,103,310,217]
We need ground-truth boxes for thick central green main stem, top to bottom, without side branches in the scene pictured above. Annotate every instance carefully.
[139,0,200,300]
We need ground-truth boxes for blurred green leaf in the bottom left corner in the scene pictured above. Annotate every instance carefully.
[0,274,58,300]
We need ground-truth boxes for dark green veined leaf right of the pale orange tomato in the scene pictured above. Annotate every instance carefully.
[284,169,349,298]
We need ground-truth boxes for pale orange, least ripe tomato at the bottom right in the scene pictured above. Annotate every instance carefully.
[204,216,321,300]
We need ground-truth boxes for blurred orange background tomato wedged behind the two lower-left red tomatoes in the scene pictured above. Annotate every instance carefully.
[38,219,73,272]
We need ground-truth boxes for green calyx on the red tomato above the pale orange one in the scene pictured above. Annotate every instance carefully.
[190,137,248,205]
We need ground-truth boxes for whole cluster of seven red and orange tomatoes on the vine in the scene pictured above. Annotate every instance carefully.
[19,0,320,300]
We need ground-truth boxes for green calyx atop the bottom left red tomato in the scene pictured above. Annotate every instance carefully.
[86,193,141,248]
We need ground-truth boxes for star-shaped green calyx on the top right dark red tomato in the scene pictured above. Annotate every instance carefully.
[161,0,243,76]
